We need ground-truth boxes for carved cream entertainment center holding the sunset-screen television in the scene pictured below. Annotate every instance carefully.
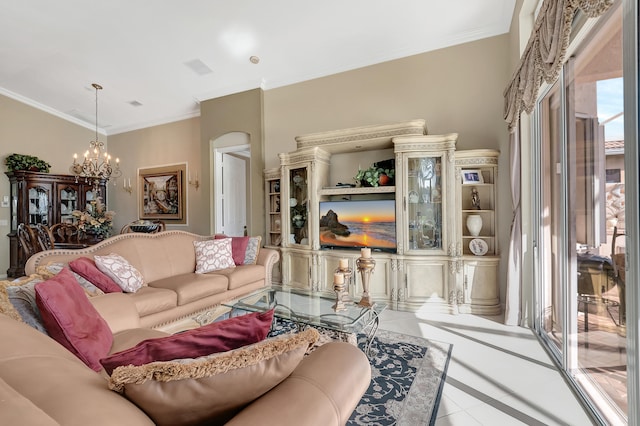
[265,120,501,315]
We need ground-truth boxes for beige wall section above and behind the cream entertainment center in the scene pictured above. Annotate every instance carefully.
[264,34,511,301]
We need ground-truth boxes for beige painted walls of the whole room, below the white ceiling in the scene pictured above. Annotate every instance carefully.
[0,35,511,300]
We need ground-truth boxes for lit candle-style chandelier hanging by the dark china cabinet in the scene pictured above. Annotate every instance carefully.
[69,83,122,191]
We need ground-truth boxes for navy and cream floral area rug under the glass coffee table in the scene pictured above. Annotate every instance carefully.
[272,320,453,426]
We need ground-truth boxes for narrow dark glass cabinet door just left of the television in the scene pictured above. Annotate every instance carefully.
[289,167,309,245]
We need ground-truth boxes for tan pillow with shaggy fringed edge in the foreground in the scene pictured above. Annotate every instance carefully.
[109,328,318,425]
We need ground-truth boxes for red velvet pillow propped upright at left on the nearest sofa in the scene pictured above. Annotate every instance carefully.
[35,268,113,371]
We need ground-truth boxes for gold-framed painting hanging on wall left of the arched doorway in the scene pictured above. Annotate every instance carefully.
[138,163,187,223]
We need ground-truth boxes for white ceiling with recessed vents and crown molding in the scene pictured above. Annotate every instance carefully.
[0,0,515,134]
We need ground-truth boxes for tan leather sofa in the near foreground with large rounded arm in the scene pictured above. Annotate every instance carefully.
[0,302,371,426]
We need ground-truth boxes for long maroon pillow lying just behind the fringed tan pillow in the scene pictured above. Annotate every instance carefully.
[100,309,273,375]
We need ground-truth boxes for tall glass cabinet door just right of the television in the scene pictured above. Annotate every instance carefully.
[405,157,443,250]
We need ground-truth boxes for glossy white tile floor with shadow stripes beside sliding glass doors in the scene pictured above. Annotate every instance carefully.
[380,310,593,426]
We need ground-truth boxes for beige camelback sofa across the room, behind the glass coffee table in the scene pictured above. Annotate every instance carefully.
[25,231,279,329]
